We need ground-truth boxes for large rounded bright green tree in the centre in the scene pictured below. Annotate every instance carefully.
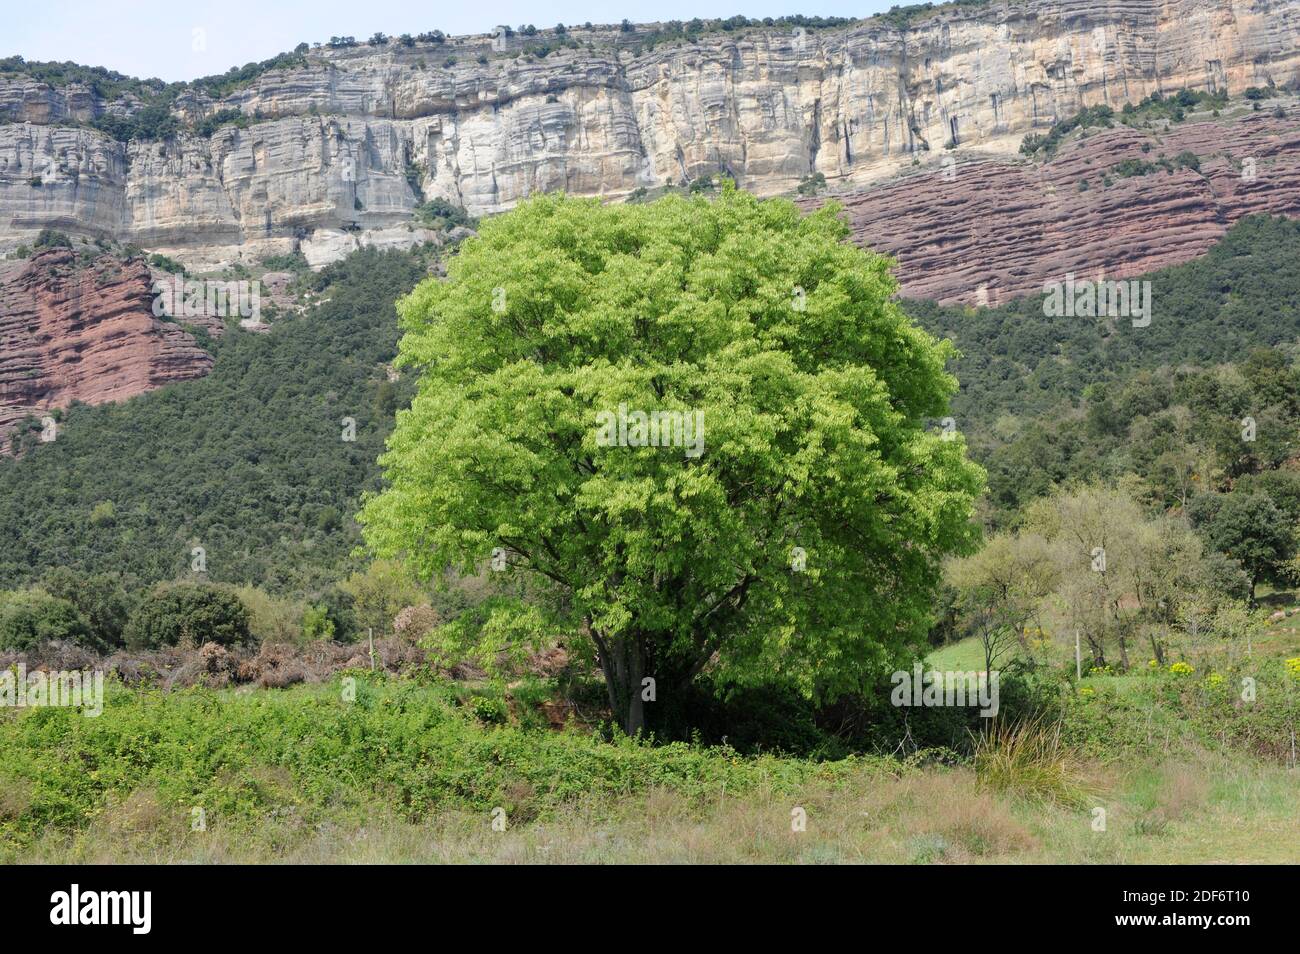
[360,188,983,733]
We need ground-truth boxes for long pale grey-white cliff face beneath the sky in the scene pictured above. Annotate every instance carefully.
[0,0,1300,265]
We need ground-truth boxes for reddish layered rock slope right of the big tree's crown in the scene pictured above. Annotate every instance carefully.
[810,107,1300,304]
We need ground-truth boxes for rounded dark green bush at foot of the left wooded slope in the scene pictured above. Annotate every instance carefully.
[126,584,252,649]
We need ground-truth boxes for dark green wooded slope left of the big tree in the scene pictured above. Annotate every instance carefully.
[0,250,425,598]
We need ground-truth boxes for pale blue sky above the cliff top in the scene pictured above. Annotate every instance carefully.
[10,0,911,82]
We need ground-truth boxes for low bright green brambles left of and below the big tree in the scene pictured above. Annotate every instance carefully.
[0,673,898,846]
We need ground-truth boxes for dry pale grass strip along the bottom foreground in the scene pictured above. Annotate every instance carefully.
[30,756,1300,864]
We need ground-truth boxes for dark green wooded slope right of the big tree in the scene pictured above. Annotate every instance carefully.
[907,217,1300,524]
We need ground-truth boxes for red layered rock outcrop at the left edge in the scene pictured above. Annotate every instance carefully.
[0,248,212,447]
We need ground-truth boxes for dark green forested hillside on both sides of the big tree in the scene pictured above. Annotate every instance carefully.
[0,218,1300,595]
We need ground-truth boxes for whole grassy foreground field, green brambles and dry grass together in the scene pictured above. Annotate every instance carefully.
[0,665,1300,863]
